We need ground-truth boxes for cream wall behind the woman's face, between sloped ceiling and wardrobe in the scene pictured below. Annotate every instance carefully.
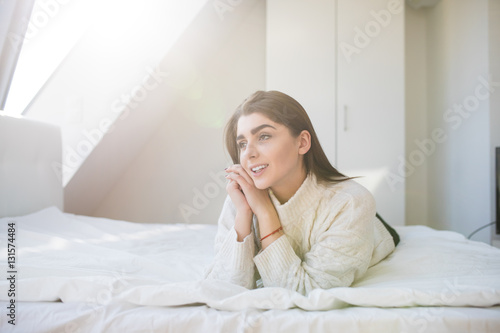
[92,2,265,224]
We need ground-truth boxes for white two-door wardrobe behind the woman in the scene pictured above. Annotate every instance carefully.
[266,0,404,225]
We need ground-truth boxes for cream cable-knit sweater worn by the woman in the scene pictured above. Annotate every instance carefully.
[205,175,394,294]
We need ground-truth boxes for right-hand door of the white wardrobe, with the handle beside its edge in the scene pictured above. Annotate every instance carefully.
[336,0,405,225]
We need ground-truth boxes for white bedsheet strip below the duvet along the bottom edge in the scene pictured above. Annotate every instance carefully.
[0,302,500,333]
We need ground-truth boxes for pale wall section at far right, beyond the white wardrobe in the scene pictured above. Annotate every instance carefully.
[427,0,491,242]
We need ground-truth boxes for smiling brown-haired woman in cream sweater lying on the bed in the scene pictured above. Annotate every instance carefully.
[206,91,397,294]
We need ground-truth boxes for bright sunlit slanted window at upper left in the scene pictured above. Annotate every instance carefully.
[1,0,206,185]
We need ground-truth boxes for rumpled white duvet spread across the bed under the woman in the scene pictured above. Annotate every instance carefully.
[0,208,500,311]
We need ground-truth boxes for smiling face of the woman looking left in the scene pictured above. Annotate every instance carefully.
[236,112,309,200]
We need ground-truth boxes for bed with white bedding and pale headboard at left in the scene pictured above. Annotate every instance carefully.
[0,113,500,332]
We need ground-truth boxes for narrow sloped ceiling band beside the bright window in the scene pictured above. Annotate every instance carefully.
[65,0,259,215]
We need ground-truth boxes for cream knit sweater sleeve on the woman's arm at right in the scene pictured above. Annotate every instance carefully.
[254,185,375,294]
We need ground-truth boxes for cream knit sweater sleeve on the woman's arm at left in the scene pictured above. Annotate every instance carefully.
[205,196,255,289]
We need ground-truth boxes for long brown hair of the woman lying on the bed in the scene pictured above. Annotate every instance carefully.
[225,91,350,182]
